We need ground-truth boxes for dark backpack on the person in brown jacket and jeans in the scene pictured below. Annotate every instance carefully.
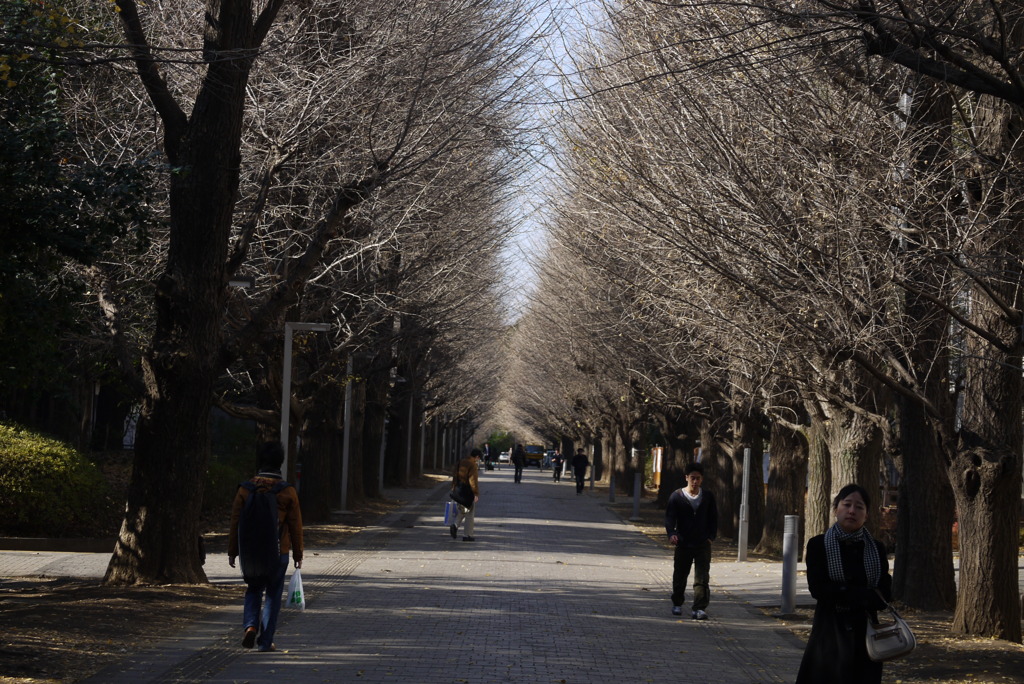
[239,480,292,583]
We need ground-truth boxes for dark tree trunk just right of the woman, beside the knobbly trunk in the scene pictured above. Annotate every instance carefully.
[893,79,956,610]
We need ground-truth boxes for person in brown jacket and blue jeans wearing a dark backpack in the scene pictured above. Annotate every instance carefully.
[227,441,302,651]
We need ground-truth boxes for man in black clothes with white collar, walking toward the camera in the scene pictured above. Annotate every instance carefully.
[665,463,718,619]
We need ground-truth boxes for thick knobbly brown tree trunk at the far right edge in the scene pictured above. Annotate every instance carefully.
[949,90,1024,642]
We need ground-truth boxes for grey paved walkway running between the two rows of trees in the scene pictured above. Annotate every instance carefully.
[0,469,809,684]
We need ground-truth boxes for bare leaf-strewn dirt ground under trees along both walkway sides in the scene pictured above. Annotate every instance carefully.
[0,476,1024,684]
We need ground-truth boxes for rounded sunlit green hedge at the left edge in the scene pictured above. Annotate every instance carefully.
[0,422,118,537]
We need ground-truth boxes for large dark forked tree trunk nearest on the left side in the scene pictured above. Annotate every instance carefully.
[104,0,275,584]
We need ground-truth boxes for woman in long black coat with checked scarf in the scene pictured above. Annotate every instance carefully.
[797,484,893,684]
